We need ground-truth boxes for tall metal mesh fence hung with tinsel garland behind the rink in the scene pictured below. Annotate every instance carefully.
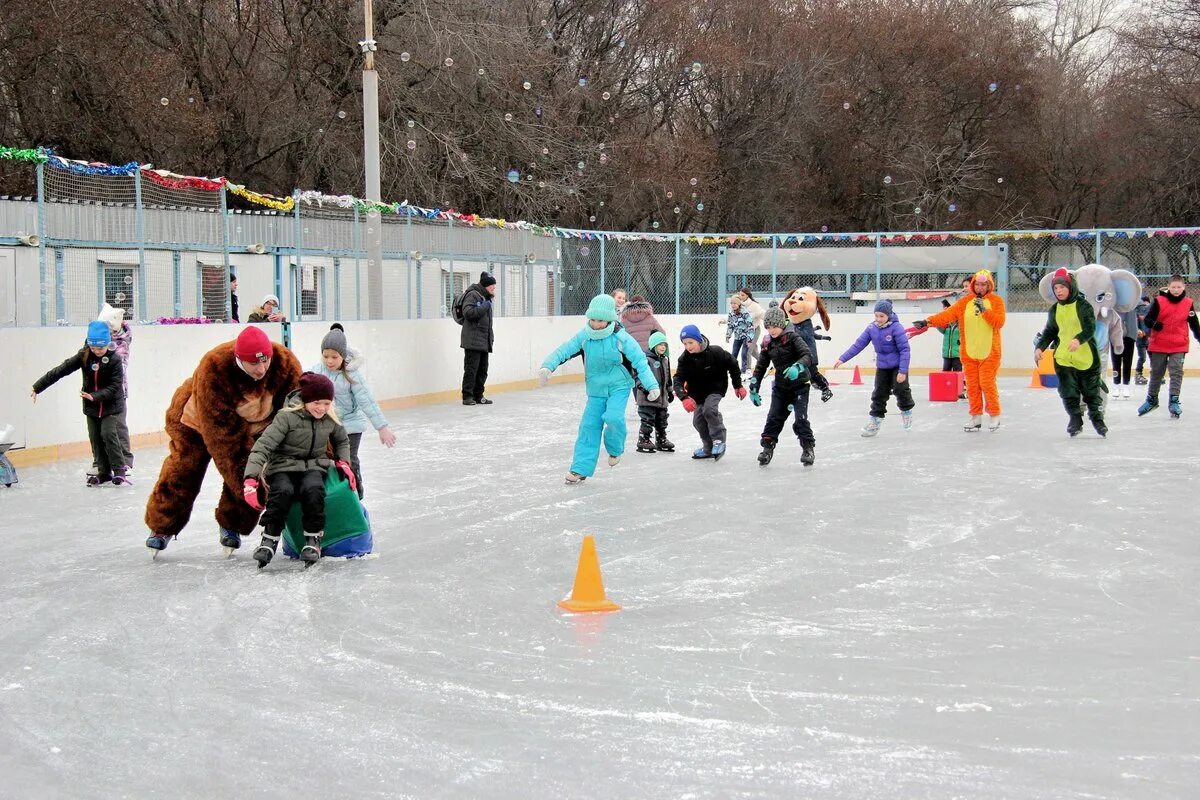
[0,164,1200,325]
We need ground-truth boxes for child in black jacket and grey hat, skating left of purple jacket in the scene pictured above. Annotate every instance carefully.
[750,308,817,467]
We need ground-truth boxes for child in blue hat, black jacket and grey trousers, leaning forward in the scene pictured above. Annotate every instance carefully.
[674,325,746,461]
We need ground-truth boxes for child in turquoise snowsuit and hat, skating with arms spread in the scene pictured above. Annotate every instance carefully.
[539,294,660,483]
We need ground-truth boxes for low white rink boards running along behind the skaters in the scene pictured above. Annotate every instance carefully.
[0,309,1045,447]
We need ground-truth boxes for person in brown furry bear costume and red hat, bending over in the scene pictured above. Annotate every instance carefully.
[145,326,304,551]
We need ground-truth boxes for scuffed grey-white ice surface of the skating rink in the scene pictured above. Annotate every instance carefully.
[0,378,1200,800]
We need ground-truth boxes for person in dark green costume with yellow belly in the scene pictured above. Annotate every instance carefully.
[1033,269,1109,437]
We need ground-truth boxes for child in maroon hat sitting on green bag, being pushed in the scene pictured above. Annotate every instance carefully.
[242,372,356,569]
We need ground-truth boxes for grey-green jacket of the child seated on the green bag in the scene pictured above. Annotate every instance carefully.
[245,392,350,477]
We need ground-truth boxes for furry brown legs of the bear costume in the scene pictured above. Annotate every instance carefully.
[145,380,258,536]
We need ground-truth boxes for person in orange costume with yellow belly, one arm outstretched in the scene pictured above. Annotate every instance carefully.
[925,270,1006,427]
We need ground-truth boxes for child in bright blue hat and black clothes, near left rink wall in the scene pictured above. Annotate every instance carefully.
[32,320,130,486]
